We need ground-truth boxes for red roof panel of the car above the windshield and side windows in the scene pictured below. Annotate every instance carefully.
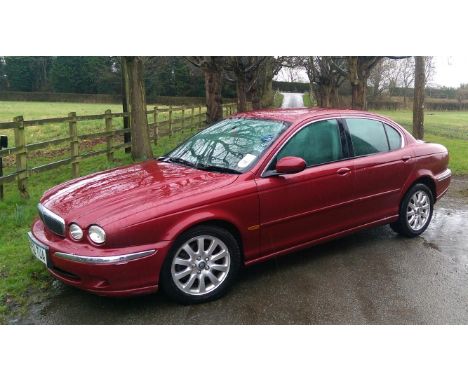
[232,107,388,123]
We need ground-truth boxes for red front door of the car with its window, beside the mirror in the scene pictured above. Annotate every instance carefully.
[256,119,354,254]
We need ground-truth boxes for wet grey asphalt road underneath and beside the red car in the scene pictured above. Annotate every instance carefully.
[16,178,468,324]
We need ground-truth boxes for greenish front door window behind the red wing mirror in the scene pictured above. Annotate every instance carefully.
[274,119,343,167]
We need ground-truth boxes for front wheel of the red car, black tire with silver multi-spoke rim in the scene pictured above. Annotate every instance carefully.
[160,225,241,304]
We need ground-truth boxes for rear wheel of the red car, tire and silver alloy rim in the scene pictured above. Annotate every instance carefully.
[390,183,434,237]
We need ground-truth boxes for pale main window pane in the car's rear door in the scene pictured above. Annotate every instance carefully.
[346,118,389,156]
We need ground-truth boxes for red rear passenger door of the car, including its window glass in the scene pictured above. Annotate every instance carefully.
[345,118,412,224]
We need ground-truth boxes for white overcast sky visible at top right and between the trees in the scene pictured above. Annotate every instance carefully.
[278,56,468,88]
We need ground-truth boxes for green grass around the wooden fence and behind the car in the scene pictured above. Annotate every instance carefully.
[0,99,468,322]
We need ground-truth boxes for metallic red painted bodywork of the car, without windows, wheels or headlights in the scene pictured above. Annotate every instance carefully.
[28,109,450,295]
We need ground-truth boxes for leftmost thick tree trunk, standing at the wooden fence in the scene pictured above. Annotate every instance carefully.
[123,57,153,161]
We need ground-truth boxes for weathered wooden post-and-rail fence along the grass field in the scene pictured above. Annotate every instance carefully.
[0,104,237,196]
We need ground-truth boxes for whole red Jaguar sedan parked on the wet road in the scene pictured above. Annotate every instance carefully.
[29,109,451,303]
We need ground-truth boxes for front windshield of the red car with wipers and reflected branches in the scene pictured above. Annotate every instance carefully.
[161,118,288,173]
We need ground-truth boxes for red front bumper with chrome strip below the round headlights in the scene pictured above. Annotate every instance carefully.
[31,219,171,296]
